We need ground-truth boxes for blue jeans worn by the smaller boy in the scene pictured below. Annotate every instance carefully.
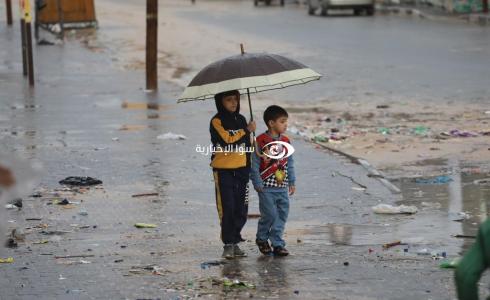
[257,189,289,247]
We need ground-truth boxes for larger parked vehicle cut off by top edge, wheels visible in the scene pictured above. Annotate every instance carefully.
[308,0,374,16]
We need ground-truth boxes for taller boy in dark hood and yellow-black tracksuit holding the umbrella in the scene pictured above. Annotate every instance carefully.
[209,91,255,259]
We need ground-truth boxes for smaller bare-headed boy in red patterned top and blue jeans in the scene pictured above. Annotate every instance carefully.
[250,105,296,256]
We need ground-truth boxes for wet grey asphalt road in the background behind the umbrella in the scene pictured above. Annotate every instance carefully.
[168,1,490,103]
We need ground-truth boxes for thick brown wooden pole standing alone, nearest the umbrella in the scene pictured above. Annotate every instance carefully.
[146,0,158,90]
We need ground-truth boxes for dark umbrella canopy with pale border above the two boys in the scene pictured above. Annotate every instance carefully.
[177,53,321,102]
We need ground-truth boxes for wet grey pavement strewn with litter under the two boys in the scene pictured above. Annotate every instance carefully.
[0,5,460,299]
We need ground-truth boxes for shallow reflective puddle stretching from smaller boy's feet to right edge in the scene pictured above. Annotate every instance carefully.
[287,161,490,256]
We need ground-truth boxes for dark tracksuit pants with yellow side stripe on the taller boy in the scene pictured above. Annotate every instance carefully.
[213,170,249,244]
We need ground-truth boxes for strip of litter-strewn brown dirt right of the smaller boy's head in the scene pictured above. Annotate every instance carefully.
[289,101,490,169]
